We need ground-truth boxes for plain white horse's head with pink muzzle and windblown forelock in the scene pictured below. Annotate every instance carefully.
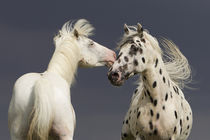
[56,19,116,67]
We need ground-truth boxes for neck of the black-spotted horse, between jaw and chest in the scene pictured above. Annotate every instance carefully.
[141,56,171,101]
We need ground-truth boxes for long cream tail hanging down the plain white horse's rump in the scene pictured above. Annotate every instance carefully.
[27,78,53,140]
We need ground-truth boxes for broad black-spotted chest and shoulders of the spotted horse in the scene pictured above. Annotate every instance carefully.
[124,85,192,139]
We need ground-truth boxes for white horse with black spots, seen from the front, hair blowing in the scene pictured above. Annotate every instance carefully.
[108,23,192,140]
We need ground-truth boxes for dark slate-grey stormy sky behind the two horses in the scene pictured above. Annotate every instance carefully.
[0,0,210,140]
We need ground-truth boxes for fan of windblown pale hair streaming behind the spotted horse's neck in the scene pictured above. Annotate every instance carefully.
[161,38,192,88]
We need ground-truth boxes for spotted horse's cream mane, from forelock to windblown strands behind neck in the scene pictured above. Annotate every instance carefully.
[119,26,192,88]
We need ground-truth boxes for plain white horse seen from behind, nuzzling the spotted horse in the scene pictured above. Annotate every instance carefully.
[8,19,116,140]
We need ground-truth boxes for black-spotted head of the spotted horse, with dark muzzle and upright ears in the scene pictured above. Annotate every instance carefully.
[108,23,161,86]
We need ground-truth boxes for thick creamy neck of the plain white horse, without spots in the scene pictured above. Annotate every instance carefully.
[47,41,80,85]
